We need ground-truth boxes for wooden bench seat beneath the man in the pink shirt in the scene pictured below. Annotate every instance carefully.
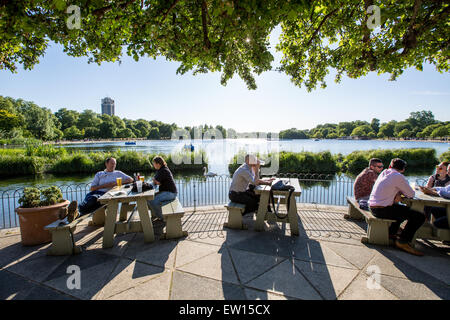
[344,197,395,245]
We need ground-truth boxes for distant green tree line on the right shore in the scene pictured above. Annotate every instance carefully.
[280,110,450,139]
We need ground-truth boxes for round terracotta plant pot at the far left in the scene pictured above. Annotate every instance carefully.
[16,200,70,246]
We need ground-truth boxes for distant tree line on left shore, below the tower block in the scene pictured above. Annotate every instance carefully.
[0,96,227,141]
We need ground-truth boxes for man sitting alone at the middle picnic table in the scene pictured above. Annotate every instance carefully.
[228,154,275,214]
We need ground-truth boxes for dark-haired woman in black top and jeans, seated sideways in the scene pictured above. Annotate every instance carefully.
[147,156,178,221]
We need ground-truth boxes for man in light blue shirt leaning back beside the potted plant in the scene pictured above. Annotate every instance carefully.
[60,157,134,222]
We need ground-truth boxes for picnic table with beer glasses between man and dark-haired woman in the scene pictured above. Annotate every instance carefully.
[98,186,155,248]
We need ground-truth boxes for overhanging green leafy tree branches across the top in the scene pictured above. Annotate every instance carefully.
[0,0,450,90]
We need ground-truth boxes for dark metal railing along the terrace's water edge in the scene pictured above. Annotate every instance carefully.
[0,173,354,229]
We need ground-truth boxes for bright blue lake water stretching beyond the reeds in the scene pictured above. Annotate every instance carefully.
[0,139,450,190]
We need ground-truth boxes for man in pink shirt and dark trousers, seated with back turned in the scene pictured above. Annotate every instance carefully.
[369,158,425,256]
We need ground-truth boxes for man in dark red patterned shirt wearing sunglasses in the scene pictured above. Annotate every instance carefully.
[353,158,383,210]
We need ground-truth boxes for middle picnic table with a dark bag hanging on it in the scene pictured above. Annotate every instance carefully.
[255,178,302,236]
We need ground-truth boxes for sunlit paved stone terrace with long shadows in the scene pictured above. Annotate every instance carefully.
[0,204,450,300]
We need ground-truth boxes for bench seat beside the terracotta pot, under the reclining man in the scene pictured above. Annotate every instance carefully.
[44,205,106,256]
